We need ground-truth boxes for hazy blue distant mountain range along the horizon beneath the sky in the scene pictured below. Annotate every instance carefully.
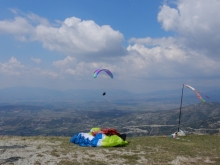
[0,87,220,104]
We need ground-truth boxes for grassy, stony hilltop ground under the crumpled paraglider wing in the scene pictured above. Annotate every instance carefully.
[0,135,220,165]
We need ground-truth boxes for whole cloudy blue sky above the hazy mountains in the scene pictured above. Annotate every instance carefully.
[0,0,220,93]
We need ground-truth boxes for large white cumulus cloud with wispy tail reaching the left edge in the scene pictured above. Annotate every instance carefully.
[0,11,126,60]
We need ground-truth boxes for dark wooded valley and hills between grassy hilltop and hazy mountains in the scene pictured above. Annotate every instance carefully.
[0,102,220,137]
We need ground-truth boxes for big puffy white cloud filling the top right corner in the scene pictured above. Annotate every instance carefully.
[158,0,220,60]
